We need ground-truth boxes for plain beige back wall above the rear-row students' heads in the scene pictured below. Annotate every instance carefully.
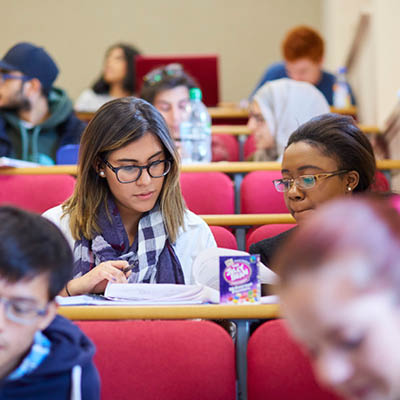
[0,0,321,101]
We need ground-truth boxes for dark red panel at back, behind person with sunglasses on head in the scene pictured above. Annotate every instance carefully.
[135,54,219,107]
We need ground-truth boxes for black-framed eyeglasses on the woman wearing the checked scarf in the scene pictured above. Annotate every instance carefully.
[103,160,172,183]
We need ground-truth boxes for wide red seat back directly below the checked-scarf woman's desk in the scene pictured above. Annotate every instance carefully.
[77,320,235,400]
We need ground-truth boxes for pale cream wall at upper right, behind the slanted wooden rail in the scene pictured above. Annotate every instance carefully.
[322,0,400,191]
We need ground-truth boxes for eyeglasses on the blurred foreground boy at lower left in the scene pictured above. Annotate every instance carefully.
[0,297,48,325]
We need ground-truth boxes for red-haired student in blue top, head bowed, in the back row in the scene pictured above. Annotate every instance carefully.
[252,26,355,105]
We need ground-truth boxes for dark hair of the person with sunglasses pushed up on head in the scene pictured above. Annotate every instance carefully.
[140,67,199,104]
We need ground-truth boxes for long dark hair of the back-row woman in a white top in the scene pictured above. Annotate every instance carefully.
[92,43,140,95]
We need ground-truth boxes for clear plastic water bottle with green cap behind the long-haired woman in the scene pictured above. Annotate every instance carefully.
[180,88,211,164]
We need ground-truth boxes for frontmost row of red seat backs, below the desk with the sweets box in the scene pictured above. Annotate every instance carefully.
[77,320,338,400]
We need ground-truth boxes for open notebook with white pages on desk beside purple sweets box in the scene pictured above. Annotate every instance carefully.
[57,248,277,305]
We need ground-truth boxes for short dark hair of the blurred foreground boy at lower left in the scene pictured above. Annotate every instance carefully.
[0,206,73,300]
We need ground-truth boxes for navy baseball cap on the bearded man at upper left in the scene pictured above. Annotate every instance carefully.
[0,42,58,92]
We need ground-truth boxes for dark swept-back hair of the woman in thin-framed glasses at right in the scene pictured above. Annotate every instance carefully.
[286,114,376,192]
